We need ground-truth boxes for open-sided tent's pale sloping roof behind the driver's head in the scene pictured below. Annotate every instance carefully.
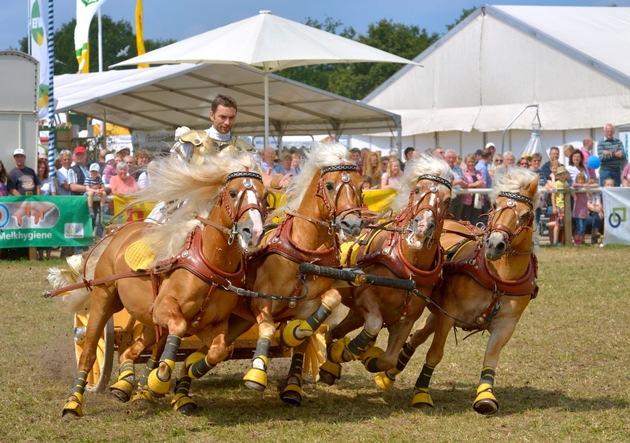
[55,64,400,136]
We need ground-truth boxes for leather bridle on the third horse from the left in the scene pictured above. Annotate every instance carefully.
[397,174,452,247]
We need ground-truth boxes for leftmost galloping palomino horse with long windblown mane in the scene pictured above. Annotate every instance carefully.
[55,153,266,416]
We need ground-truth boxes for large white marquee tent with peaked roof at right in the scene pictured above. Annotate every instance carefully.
[364,6,630,153]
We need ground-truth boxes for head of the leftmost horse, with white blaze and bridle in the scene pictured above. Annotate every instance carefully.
[217,171,267,249]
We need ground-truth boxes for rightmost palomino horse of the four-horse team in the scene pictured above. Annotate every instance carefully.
[379,168,538,414]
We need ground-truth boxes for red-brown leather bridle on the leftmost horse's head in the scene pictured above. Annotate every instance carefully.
[197,171,267,245]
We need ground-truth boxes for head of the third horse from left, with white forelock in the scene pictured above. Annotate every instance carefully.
[394,156,453,249]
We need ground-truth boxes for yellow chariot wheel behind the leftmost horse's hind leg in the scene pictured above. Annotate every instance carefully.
[74,314,114,392]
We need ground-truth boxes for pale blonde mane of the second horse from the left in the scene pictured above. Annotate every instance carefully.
[276,142,354,216]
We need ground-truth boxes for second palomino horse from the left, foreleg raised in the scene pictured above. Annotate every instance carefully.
[168,143,362,412]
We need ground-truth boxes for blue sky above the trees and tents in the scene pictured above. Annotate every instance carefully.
[0,0,630,50]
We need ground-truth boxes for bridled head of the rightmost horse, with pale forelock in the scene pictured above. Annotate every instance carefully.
[483,168,538,260]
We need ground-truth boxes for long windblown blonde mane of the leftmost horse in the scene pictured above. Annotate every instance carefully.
[133,150,257,263]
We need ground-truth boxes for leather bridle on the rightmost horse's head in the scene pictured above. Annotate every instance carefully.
[484,191,534,255]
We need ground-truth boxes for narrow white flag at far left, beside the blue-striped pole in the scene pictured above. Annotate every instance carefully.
[28,0,50,120]
